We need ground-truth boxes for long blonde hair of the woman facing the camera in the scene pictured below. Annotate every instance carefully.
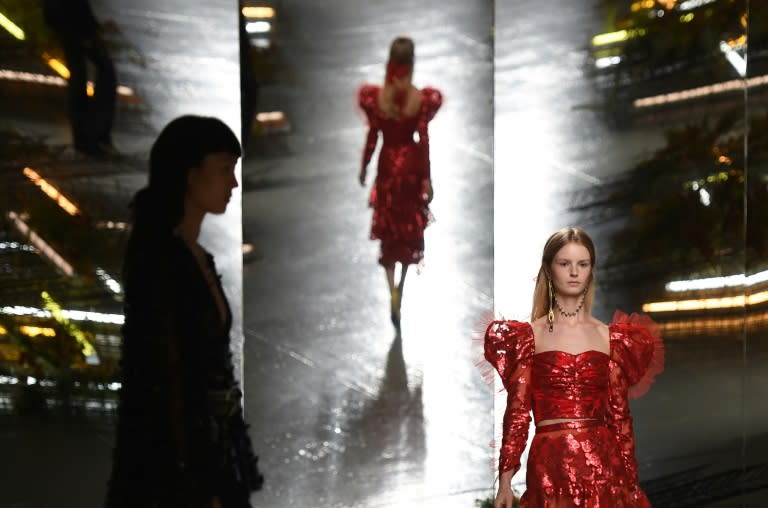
[531,227,595,322]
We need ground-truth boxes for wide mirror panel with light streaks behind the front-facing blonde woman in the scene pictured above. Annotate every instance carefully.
[495,0,757,507]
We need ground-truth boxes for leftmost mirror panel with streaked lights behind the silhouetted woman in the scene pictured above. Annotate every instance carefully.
[0,0,241,507]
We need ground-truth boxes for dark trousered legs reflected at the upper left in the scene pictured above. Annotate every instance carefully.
[43,0,117,155]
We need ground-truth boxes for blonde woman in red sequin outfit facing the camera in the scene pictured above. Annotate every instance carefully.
[485,228,664,508]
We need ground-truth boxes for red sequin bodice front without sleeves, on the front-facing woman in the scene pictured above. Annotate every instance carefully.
[531,351,609,422]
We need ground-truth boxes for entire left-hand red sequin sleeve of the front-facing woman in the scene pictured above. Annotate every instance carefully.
[484,321,534,474]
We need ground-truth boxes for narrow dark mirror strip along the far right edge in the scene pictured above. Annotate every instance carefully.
[743,0,768,506]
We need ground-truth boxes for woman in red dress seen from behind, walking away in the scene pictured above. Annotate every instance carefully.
[358,37,442,327]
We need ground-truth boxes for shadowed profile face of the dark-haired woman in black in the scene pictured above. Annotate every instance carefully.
[187,152,240,214]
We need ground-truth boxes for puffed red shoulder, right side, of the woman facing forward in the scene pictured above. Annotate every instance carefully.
[609,310,664,399]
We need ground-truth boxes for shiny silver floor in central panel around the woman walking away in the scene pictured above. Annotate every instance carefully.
[243,0,493,507]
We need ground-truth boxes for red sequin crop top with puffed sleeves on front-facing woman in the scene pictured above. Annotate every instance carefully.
[484,311,664,486]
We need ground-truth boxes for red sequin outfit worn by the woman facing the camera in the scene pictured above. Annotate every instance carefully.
[484,311,664,508]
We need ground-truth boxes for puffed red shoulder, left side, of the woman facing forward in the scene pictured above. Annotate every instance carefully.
[483,320,534,389]
